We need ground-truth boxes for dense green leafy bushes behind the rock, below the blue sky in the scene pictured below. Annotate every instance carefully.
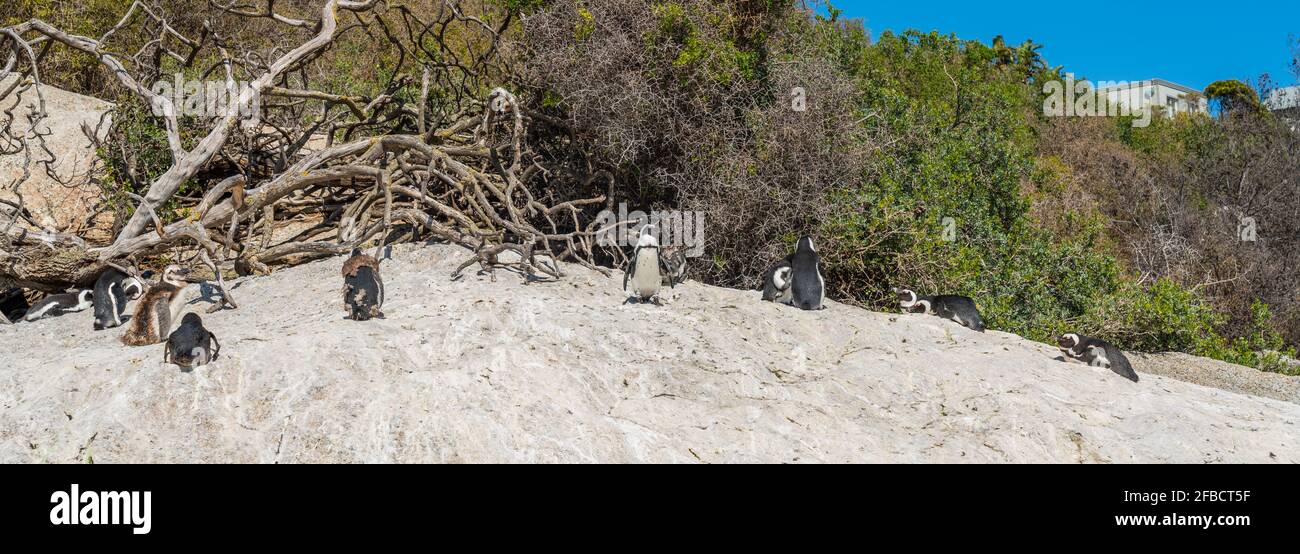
[512,1,1295,372]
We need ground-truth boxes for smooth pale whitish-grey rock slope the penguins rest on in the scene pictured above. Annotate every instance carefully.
[0,246,1300,463]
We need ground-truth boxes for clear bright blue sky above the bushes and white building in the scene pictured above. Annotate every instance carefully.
[832,0,1300,90]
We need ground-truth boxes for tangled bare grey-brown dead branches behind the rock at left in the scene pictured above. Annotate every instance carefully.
[0,0,608,307]
